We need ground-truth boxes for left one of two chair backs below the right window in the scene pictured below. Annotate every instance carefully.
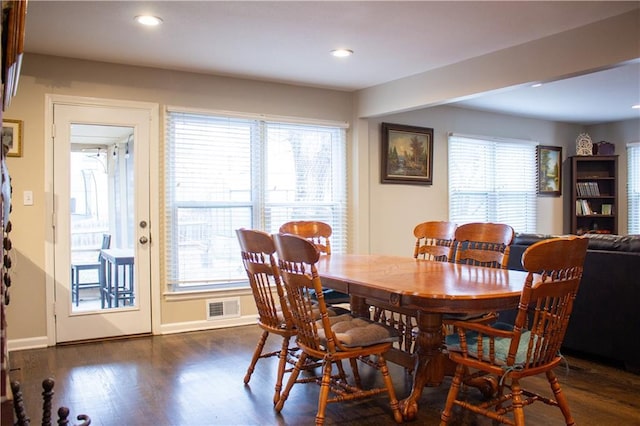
[413,221,456,262]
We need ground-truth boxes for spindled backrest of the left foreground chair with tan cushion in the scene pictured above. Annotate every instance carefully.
[273,234,340,352]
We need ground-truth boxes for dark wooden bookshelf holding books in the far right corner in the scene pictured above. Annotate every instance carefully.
[570,155,618,235]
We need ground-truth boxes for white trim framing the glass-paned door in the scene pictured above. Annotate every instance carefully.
[44,94,161,346]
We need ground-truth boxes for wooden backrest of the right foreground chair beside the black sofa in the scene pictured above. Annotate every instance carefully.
[507,236,589,367]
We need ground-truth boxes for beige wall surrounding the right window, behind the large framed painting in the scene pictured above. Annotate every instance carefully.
[363,106,583,255]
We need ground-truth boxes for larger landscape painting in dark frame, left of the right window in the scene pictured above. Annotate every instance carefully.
[380,123,433,185]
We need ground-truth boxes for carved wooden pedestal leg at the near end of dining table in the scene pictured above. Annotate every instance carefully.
[400,311,447,421]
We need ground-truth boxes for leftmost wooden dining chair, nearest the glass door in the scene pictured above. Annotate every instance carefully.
[236,229,310,404]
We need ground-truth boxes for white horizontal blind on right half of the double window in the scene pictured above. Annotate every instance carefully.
[264,122,347,246]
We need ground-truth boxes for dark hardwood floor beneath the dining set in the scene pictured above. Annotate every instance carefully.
[9,326,640,426]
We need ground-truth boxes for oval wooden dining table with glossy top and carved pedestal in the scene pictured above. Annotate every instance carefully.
[316,254,527,420]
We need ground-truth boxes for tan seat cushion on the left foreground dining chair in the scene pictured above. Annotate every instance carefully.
[316,314,399,347]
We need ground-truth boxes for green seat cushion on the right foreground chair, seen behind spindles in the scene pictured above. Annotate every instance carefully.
[445,323,531,365]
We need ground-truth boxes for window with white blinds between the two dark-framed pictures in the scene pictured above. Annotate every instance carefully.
[449,135,537,232]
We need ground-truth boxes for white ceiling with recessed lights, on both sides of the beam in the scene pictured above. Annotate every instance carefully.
[25,0,640,124]
